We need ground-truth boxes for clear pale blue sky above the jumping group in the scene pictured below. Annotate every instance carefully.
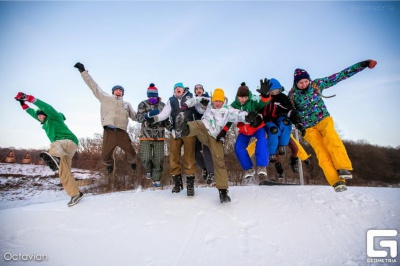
[0,1,400,149]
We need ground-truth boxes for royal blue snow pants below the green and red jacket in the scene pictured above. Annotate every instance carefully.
[235,127,269,170]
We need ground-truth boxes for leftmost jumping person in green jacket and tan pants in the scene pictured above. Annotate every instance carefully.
[15,92,83,207]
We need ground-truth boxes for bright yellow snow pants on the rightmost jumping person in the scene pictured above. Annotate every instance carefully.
[304,116,353,186]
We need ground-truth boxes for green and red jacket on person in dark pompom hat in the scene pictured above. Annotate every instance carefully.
[231,91,271,136]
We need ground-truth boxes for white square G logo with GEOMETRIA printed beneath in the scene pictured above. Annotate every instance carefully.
[367,229,398,262]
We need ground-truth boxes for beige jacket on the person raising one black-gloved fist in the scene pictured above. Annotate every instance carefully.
[81,70,136,131]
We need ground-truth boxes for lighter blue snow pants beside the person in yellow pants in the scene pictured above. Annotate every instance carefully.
[265,116,292,154]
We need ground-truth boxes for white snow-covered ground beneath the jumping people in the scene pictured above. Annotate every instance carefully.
[0,163,400,266]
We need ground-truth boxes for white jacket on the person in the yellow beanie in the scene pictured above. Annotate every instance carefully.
[186,97,248,138]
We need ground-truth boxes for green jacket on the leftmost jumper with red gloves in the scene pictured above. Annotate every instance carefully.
[26,99,79,145]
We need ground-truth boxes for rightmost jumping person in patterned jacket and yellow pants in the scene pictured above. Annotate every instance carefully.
[288,60,377,192]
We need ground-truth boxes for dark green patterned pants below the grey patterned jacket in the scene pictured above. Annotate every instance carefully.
[140,140,164,181]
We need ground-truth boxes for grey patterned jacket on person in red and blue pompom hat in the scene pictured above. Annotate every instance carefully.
[136,98,171,140]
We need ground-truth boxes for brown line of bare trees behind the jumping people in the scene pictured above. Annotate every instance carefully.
[0,125,400,193]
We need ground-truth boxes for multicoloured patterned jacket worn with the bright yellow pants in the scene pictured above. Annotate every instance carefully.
[288,61,368,128]
